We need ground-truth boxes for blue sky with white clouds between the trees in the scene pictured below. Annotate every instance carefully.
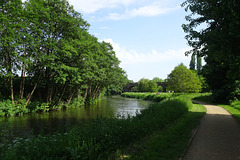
[63,0,190,82]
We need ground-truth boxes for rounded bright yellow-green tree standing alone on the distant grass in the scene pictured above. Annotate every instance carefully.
[167,64,202,93]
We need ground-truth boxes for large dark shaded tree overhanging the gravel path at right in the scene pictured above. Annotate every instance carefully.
[182,0,240,100]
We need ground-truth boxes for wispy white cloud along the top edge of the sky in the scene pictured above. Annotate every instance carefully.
[69,0,180,20]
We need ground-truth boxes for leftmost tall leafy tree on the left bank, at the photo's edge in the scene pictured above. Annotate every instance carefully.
[0,0,24,104]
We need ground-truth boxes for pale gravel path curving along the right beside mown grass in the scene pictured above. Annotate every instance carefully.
[182,102,240,160]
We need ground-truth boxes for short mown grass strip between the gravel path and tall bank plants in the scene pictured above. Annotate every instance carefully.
[119,104,206,160]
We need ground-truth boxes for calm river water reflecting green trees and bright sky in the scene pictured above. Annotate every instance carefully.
[0,96,152,136]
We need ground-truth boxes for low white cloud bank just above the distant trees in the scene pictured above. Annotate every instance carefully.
[104,39,190,81]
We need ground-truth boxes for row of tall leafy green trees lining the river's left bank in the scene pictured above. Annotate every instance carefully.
[0,0,126,116]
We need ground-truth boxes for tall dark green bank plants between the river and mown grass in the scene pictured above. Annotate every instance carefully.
[0,98,191,160]
